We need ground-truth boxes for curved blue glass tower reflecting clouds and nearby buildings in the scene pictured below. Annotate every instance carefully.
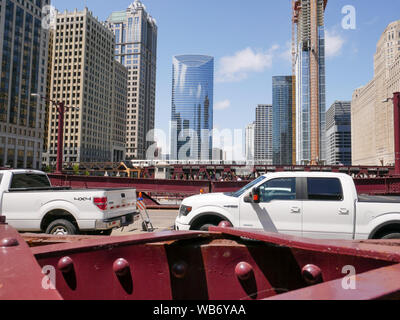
[171,55,214,160]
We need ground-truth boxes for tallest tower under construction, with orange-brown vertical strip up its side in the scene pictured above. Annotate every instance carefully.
[293,0,328,164]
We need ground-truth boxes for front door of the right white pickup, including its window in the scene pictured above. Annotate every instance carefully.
[240,178,302,236]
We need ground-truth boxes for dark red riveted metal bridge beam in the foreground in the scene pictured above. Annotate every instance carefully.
[0,215,400,301]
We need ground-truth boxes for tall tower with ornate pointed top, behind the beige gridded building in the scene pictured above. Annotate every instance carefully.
[107,0,157,159]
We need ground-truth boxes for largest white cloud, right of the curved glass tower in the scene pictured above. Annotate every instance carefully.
[217,45,279,82]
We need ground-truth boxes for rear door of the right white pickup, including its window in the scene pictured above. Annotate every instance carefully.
[303,178,354,240]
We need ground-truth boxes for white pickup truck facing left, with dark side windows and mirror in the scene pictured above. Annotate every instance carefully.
[175,172,400,240]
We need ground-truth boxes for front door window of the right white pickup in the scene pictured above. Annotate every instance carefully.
[259,178,296,202]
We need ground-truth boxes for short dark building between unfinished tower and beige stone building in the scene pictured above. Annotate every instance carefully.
[326,101,352,166]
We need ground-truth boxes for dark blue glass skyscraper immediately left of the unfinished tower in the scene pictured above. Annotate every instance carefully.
[272,76,294,165]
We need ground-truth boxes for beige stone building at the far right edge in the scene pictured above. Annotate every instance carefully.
[351,20,400,166]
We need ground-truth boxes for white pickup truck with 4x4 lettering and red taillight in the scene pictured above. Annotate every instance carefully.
[0,170,139,235]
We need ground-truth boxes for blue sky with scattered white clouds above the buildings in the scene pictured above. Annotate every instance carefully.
[52,0,400,154]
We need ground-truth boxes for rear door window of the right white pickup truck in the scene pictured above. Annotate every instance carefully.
[307,178,343,201]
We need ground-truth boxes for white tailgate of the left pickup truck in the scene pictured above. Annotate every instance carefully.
[104,189,137,219]
